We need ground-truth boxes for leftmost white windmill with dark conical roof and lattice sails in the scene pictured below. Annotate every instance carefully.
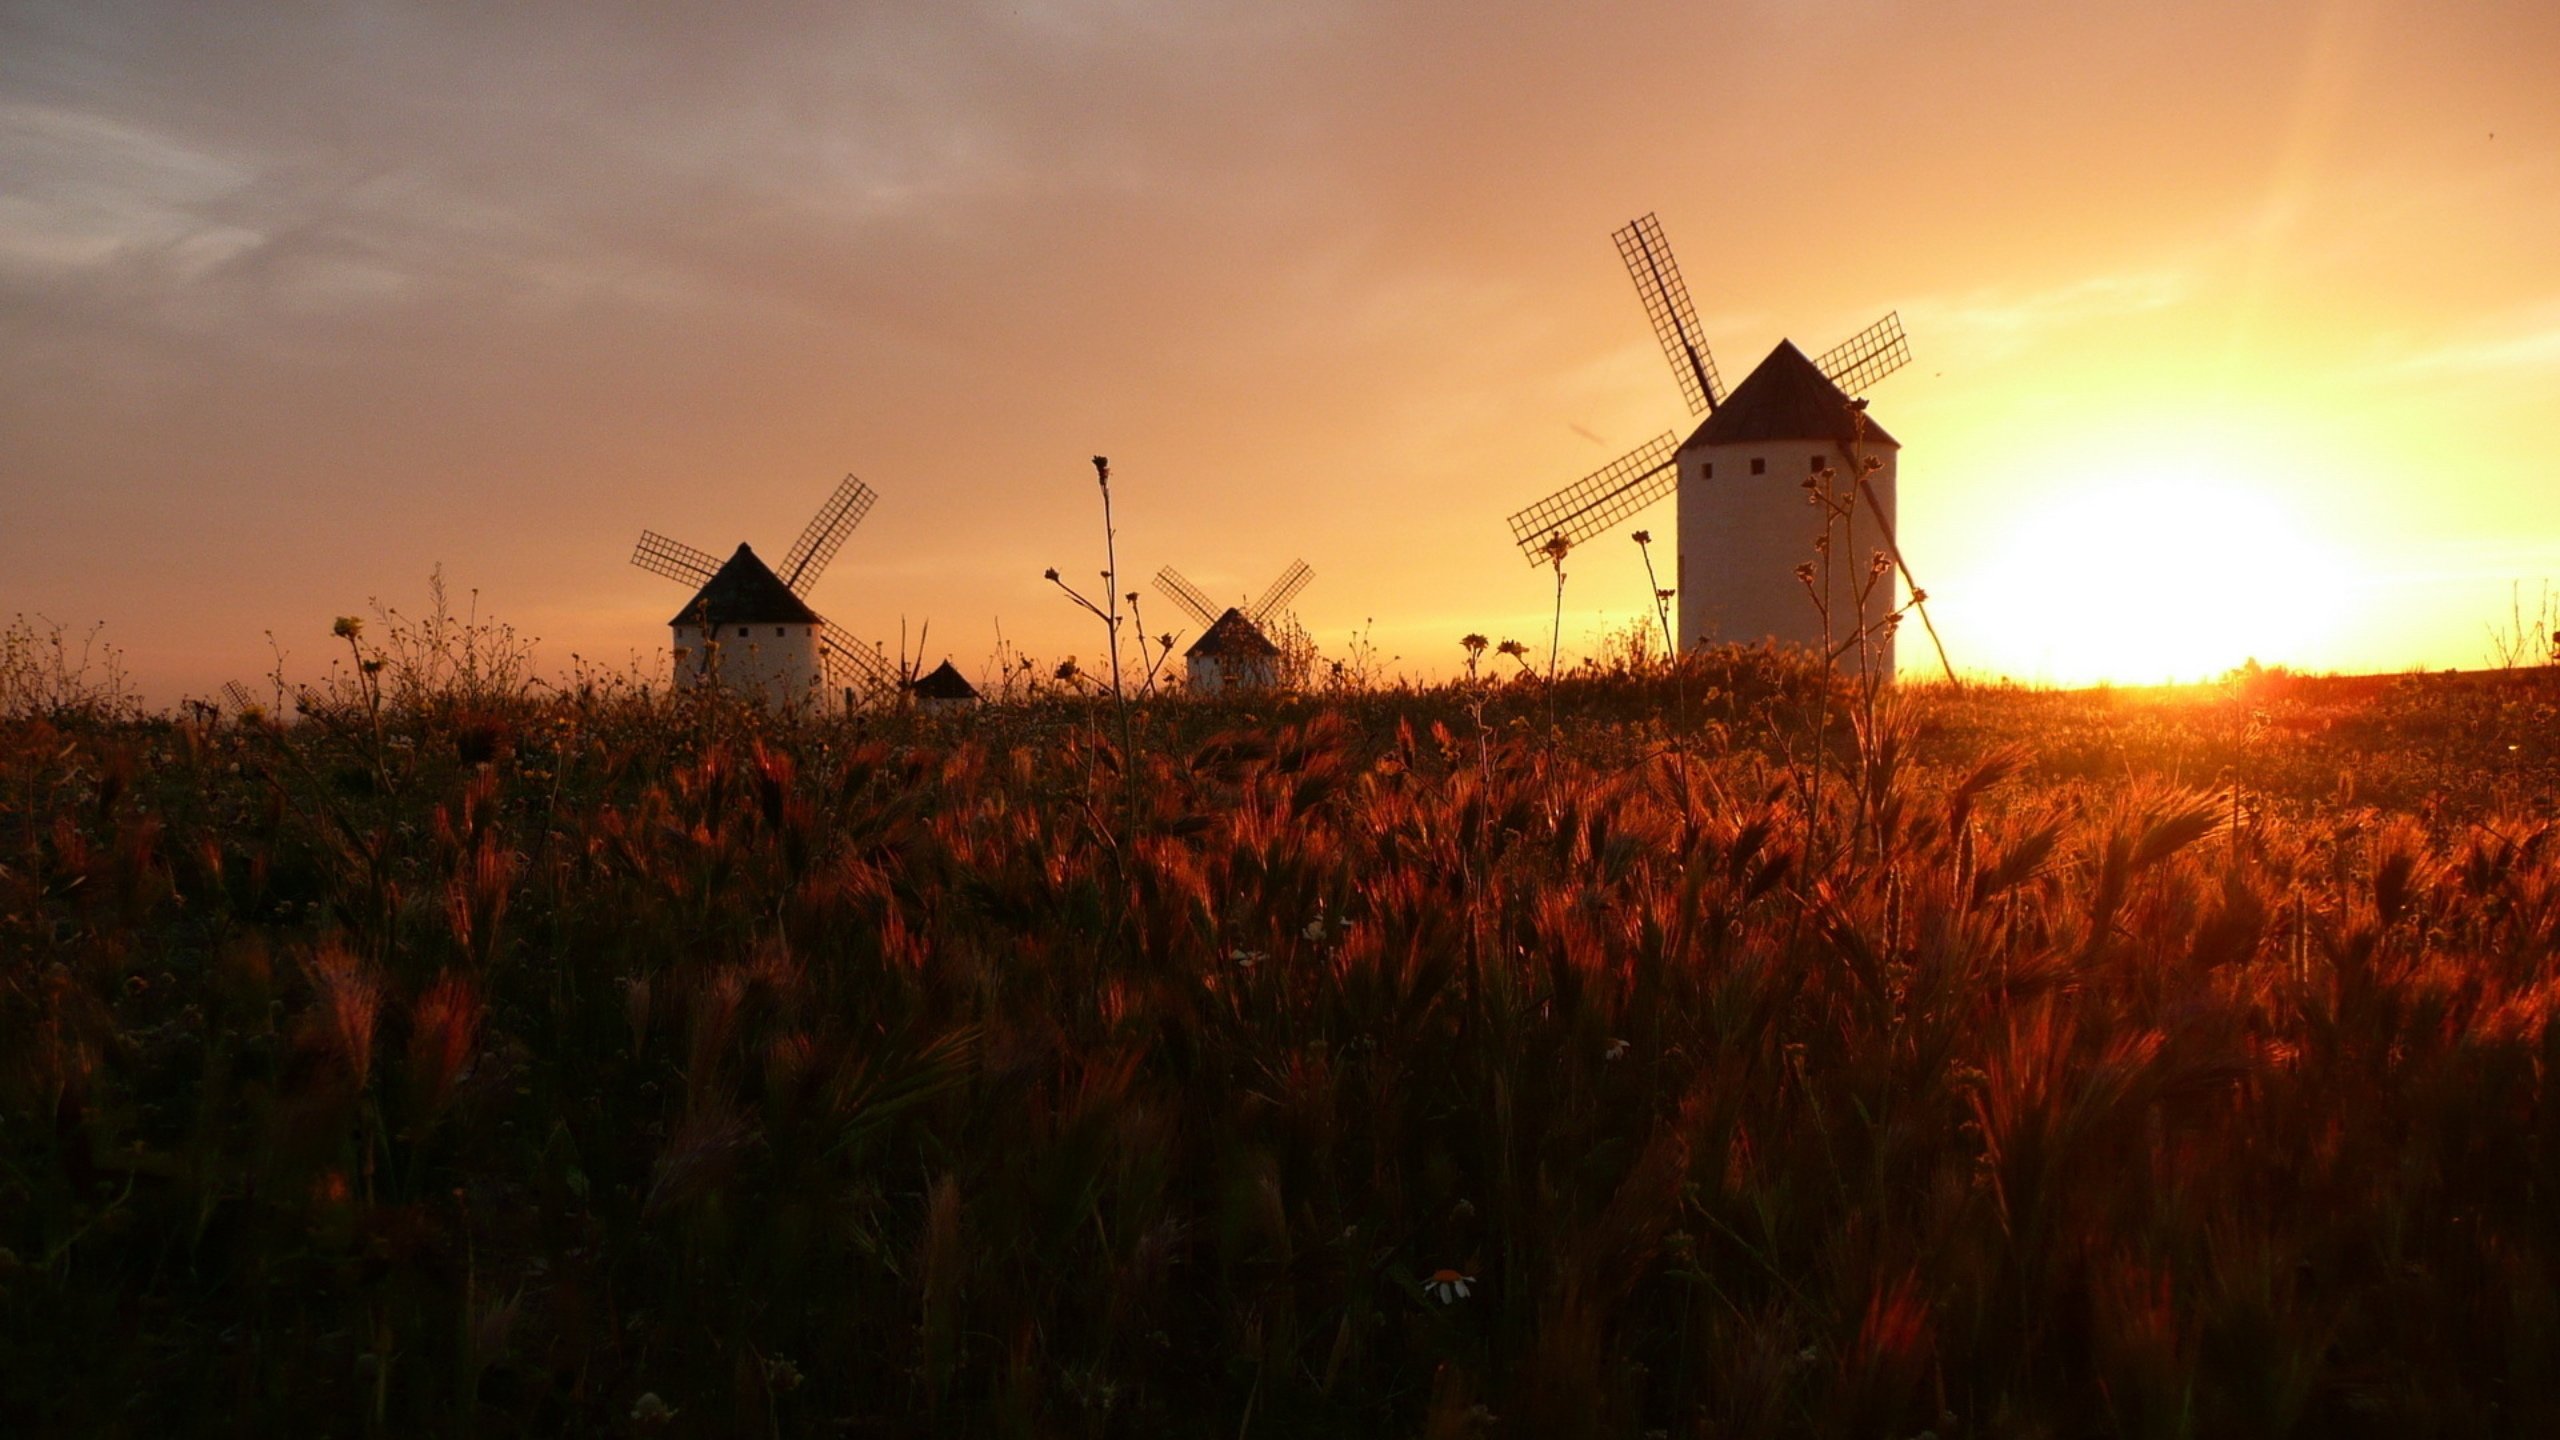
[632,474,899,705]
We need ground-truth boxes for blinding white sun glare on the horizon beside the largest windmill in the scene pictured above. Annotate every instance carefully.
[1966,456,2345,684]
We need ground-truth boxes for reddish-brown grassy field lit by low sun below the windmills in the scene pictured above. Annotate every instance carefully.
[0,656,2560,1437]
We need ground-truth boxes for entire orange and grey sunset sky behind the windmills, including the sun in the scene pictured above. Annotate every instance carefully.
[0,0,2560,702]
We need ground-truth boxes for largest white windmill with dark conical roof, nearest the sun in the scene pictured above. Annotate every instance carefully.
[1510,215,1925,674]
